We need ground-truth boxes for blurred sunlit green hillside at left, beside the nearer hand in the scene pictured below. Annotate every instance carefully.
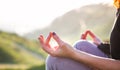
[0,31,45,64]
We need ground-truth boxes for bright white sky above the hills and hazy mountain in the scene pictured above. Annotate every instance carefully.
[0,0,113,35]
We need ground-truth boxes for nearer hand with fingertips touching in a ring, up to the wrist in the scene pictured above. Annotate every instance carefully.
[39,32,75,57]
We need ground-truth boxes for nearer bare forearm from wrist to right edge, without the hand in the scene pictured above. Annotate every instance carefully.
[71,50,120,70]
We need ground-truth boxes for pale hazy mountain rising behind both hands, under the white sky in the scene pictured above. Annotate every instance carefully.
[25,4,115,43]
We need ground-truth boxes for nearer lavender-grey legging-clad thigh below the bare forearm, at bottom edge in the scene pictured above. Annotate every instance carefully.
[46,56,91,70]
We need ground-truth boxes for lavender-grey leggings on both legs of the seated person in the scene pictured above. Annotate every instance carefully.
[46,40,107,70]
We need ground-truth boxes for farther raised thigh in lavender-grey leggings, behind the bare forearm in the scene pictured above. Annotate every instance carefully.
[73,40,108,57]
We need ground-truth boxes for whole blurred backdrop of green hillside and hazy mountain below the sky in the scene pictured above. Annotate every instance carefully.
[0,4,115,70]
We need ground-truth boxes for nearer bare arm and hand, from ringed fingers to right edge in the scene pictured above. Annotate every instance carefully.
[39,32,120,70]
